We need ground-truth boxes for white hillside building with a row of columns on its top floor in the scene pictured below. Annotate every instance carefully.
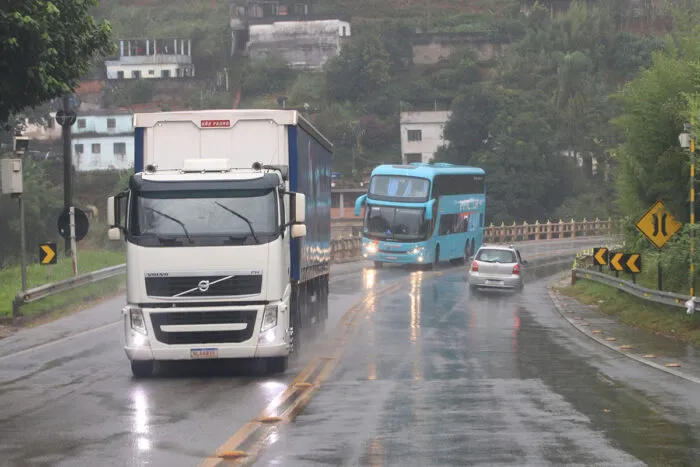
[105,39,194,79]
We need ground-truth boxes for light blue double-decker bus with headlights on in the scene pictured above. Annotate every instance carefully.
[355,163,486,267]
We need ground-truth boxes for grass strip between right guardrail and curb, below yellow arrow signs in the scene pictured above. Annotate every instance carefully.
[561,279,700,345]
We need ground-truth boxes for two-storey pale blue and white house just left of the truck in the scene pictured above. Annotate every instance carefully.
[72,110,134,172]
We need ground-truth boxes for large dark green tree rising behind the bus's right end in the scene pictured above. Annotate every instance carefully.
[437,86,578,222]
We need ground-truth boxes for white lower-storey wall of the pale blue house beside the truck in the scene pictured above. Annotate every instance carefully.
[73,134,134,172]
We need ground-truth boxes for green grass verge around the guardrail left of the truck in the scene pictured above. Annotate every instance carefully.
[0,250,125,320]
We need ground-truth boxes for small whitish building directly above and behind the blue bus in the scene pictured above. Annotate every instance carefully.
[400,111,452,164]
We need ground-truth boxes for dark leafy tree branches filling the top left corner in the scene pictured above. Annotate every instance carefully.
[0,0,112,122]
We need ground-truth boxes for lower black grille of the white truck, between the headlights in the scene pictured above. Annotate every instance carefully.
[151,310,257,345]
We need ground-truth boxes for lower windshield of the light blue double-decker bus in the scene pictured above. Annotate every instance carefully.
[364,206,428,242]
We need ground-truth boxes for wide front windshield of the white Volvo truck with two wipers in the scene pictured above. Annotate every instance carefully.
[129,190,279,245]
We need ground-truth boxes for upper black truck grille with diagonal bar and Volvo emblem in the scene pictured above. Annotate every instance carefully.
[146,275,262,298]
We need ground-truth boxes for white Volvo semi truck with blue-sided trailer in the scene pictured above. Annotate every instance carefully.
[107,110,332,377]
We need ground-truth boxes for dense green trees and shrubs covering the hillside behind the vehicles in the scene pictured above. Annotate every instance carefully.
[93,0,669,228]
